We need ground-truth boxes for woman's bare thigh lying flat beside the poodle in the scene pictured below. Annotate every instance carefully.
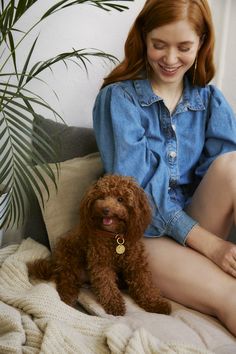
[144,237,236,318]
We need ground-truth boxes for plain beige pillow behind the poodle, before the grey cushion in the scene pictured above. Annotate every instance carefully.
[39,153,103,248]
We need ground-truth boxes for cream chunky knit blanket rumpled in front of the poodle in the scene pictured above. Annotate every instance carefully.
[0,239,214,354]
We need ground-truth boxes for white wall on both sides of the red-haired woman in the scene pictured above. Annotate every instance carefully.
[15,0,236,126]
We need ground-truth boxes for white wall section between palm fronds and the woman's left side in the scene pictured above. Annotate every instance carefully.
[15,0,145,126]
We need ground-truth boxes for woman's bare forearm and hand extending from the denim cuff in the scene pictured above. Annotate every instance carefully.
[186,225,236,278]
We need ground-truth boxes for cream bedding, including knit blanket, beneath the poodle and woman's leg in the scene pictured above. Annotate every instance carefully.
[0,239,236,354]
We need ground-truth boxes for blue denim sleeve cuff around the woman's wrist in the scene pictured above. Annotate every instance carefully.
[166,210,197,245]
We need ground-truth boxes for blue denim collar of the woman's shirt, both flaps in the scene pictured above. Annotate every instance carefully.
[134,76,205,111]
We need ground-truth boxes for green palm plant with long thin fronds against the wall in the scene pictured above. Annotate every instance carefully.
[0,0,133,228]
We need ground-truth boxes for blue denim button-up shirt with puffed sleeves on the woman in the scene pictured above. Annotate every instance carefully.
[93,78,236,244]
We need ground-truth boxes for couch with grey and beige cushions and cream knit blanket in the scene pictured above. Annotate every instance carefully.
[0,116,236,354]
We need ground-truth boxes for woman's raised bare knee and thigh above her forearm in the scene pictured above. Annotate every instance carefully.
[186,153,236,238]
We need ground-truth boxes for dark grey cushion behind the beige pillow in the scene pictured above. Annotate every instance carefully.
[24,116,98,247]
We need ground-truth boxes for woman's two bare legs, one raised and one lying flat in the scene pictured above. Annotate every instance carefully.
[144,153,236,335]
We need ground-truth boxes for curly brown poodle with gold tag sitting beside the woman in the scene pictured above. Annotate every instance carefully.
[28,175,171,315]
